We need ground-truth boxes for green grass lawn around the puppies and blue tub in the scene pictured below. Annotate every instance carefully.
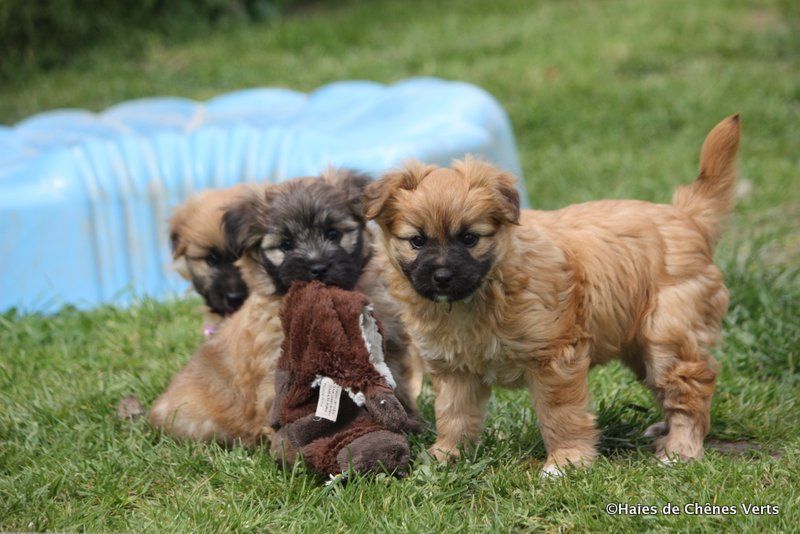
[0,0,800,532]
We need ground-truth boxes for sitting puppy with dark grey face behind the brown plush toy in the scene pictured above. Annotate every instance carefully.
[149,171,424,445]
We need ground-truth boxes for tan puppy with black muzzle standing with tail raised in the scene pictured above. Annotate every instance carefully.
[364,115,739,473]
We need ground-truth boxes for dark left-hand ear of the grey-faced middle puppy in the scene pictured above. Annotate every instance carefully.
[222,185,271,256]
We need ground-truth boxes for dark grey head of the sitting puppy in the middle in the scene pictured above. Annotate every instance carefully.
[224,171,371,295]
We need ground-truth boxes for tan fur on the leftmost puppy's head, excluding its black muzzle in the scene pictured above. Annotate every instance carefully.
[169,184,257,327]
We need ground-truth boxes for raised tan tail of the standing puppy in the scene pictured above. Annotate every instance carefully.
[672,113,740,246]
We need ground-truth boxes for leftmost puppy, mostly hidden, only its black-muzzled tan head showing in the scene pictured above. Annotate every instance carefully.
[169,184,255,336]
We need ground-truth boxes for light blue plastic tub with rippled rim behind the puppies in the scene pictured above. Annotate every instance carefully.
[0,78,527,312]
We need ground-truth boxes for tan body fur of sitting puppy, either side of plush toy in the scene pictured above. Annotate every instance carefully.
[148,186,418,446]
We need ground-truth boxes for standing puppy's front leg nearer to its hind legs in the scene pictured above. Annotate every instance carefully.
[528,344,599,475]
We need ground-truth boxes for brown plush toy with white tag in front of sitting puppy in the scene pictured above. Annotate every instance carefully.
[269,281,418,475]
